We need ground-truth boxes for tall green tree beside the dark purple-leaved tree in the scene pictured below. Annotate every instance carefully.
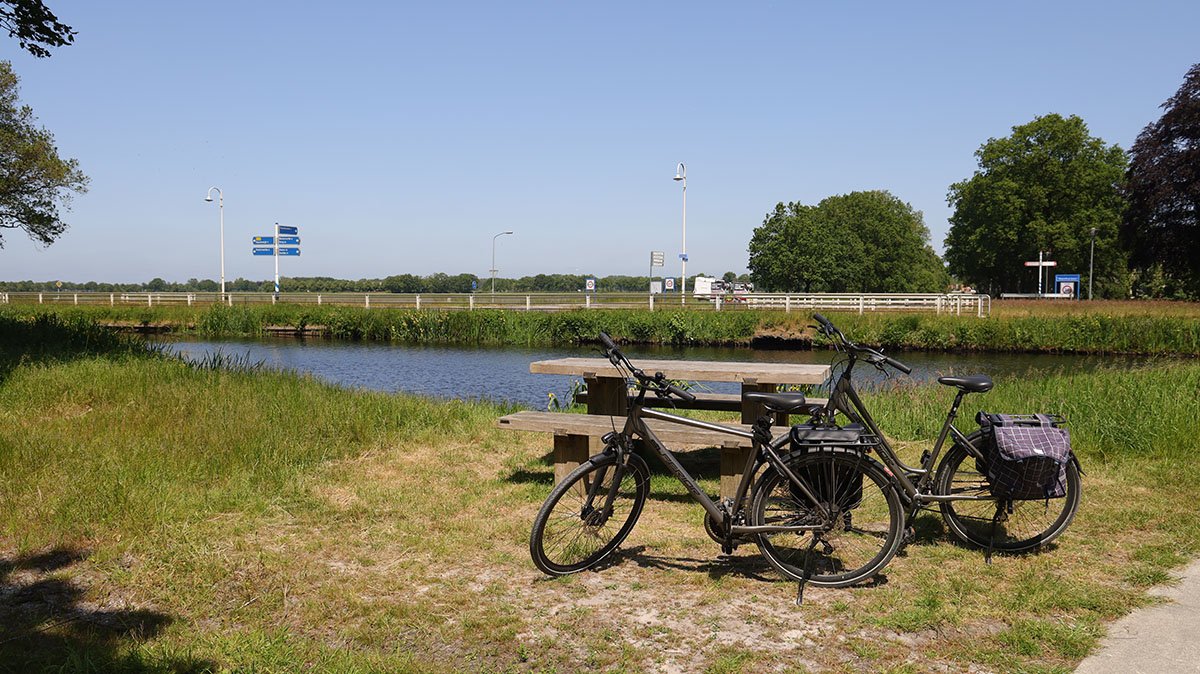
[946,114,1127,296]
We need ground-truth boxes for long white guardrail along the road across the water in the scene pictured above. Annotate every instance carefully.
[0,290,991,317]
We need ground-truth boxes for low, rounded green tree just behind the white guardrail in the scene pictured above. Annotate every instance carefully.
[748,191,949,293]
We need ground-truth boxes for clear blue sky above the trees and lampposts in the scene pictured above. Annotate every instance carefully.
[0,0,1200,282]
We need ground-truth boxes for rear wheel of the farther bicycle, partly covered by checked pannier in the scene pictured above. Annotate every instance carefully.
[934,431,1082,553]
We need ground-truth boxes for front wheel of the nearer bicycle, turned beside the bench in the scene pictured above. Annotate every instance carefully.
[529,455,650,576]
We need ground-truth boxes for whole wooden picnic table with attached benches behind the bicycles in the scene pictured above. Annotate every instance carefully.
[498,357,829,498]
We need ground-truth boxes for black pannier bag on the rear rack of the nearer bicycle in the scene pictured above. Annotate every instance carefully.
[791,423,878,511]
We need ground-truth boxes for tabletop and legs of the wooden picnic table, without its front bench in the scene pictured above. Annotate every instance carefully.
[521,357,829,497]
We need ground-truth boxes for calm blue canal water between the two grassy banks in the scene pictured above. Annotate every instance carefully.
[154,338,1147,409]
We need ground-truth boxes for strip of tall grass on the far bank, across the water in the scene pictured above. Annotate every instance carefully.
[9,302,1200,355]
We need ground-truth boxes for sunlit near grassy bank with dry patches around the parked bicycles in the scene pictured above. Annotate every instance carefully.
[0,317,1200,673]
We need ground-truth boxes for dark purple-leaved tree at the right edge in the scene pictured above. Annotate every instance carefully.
[1121,64,1200,296]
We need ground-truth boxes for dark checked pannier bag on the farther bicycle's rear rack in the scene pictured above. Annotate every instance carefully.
[976,413,1070,500]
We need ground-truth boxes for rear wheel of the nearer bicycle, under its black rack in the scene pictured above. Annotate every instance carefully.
[750,450,905,588]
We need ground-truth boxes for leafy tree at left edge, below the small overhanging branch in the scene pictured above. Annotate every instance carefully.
[0,61,88,247]
